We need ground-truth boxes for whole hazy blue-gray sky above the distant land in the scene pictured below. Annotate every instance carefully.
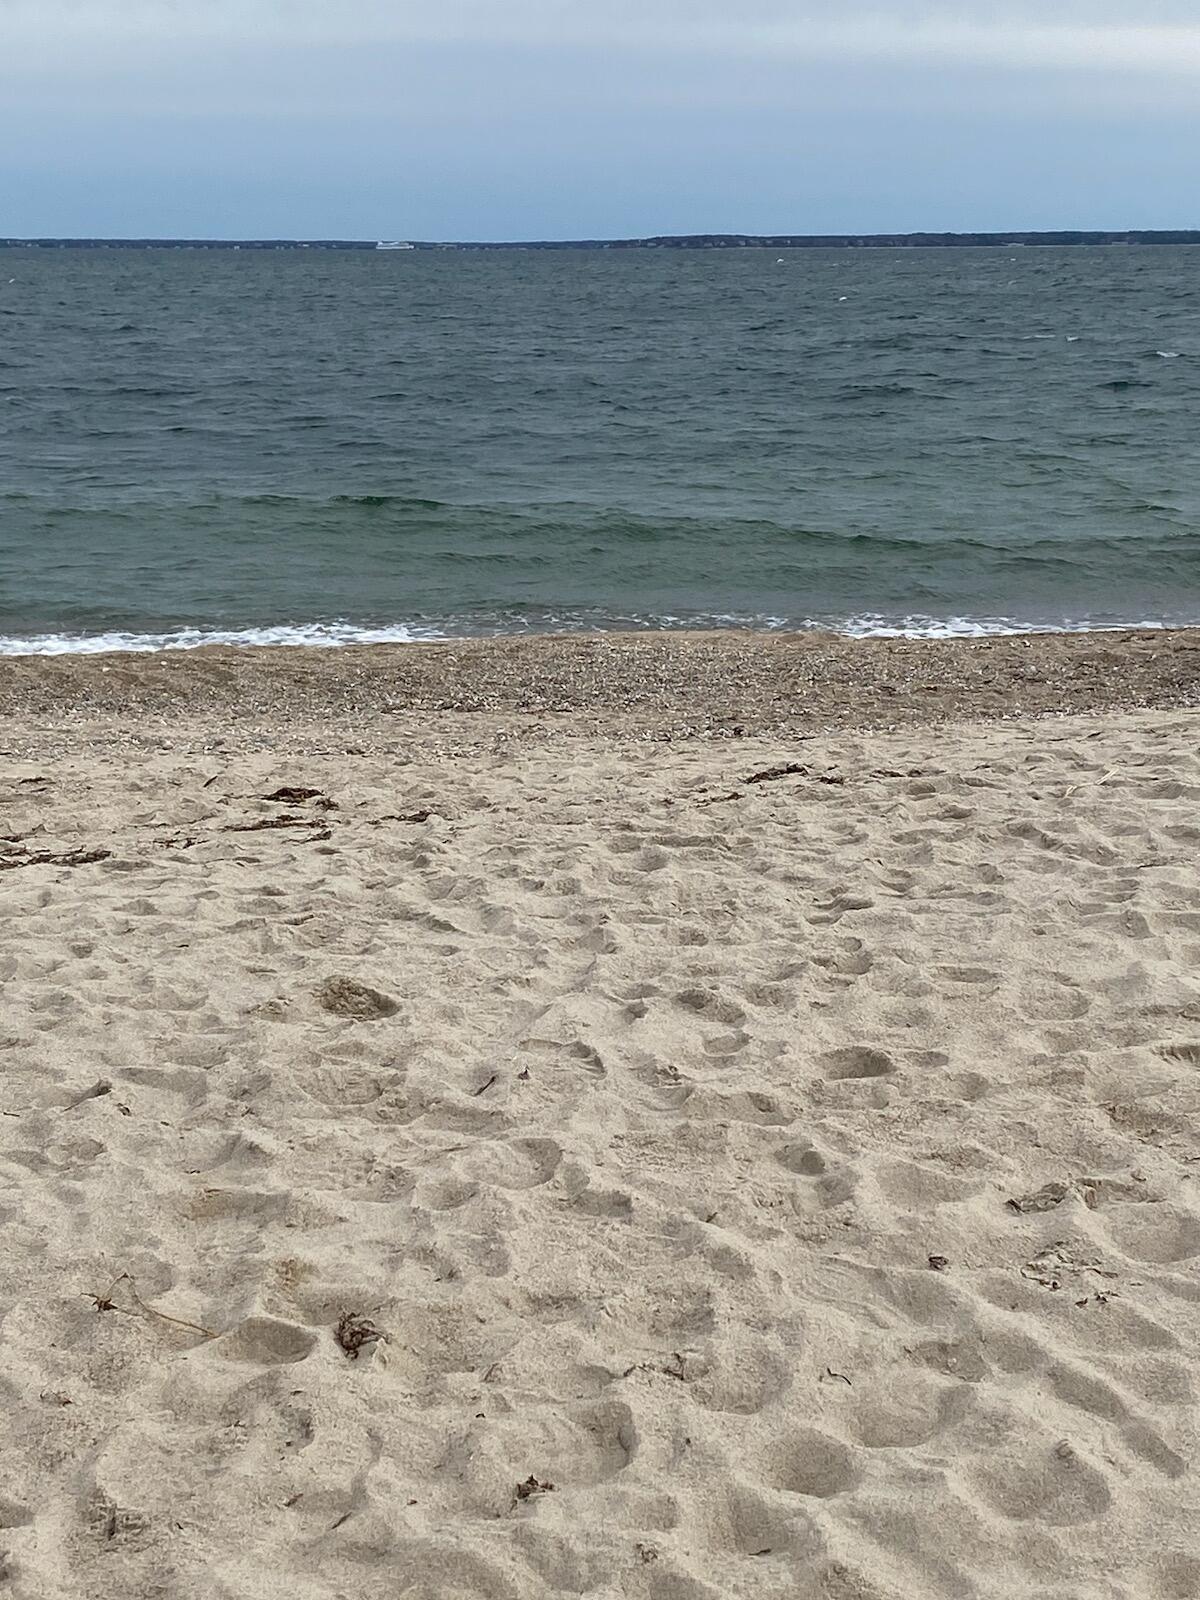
[0,0,1200,240]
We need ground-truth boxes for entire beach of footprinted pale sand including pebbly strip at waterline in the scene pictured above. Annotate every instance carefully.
[0,630,1200,1600]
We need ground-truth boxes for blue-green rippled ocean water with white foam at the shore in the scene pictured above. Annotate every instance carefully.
[0,246,1200,654]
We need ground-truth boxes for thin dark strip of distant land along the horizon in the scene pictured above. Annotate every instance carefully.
[0,229,1200,254]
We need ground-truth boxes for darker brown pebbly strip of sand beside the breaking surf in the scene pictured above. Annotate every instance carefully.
[0,629,1200,746]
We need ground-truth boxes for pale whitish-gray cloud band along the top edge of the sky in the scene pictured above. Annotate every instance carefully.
[14,0,1200,77]
